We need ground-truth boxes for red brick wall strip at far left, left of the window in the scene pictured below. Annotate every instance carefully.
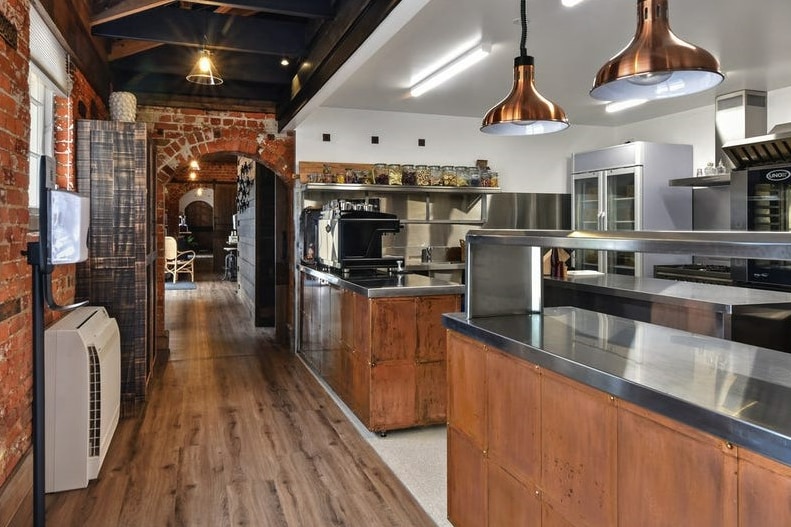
[0,0,33,485]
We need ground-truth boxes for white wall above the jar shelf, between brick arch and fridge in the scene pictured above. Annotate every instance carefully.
[296,108,615,192]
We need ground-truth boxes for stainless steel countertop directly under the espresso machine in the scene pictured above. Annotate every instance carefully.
[298,264,464,298]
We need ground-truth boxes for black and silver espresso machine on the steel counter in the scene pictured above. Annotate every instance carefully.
[317,200,404,273]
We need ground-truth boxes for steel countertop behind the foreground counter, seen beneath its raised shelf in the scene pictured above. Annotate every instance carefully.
[545,274,791,313]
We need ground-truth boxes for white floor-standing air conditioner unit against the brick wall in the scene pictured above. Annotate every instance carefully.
[44,306,121,492]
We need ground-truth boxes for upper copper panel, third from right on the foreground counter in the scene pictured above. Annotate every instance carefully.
[541,370,620,526]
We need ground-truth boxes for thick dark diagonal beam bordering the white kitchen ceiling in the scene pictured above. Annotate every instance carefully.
[277,0,400,130]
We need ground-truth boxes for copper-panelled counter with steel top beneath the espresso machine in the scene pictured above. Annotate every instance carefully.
[297,265,464,434]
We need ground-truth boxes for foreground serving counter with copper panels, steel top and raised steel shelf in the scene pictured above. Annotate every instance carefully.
[443,231,791,527]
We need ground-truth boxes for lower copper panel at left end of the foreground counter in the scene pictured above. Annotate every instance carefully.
[448,427,486,527]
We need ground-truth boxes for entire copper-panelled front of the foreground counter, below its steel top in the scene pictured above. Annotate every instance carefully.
[447,331,791,527]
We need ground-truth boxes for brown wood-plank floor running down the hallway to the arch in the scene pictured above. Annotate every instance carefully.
[40,275,434,527]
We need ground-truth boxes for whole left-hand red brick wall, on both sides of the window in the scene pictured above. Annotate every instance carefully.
[0,0,107,487]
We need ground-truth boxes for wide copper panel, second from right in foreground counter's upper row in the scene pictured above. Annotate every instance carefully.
[618,403,744,527]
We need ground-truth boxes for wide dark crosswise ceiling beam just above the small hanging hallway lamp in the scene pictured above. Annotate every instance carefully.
[93,8,306,57]
